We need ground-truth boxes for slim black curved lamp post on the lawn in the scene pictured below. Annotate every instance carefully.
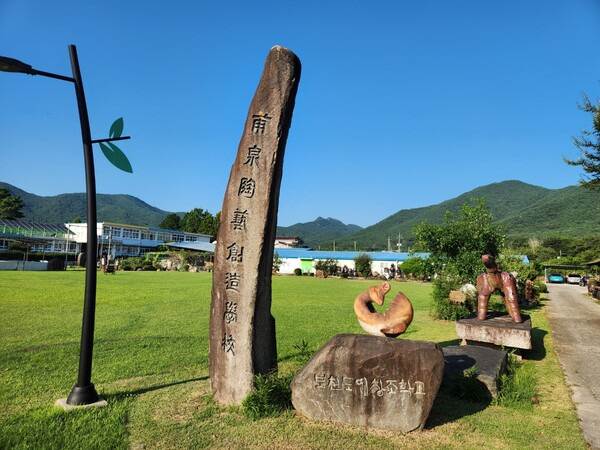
[0,45,129,405]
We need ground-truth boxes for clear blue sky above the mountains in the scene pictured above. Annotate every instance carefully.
[0,0,600,226]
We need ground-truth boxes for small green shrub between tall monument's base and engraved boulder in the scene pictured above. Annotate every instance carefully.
[242,374,292,420]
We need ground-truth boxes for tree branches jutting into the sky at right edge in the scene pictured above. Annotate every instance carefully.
[563,94,600,191]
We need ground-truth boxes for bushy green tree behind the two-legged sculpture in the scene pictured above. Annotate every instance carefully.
[413,198,505,283]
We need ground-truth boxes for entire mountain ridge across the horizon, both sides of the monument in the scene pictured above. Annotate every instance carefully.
[0,180,600,250]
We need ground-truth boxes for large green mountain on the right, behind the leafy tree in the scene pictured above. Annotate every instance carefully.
[322,180,600,250]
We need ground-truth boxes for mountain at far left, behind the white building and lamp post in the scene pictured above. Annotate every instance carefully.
[0,181,169,227]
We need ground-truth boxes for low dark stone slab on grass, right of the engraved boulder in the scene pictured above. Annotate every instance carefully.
[442,345,508,397]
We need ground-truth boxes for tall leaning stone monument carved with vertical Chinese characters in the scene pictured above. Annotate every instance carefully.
[210,46,300,405]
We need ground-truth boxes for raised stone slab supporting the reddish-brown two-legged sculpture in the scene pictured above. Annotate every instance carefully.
[456,313,531,350]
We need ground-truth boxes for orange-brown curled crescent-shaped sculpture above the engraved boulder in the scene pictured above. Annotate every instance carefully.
[354,282,414,337]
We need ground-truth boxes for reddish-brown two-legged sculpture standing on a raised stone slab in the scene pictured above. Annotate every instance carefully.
[477,255,523,323]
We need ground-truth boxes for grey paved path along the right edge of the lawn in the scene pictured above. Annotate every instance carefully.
[547,284,600,449]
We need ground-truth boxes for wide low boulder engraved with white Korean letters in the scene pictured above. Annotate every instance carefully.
[291,334,444,433]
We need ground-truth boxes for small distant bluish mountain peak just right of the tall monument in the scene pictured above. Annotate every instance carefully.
[277,217,362,247]
